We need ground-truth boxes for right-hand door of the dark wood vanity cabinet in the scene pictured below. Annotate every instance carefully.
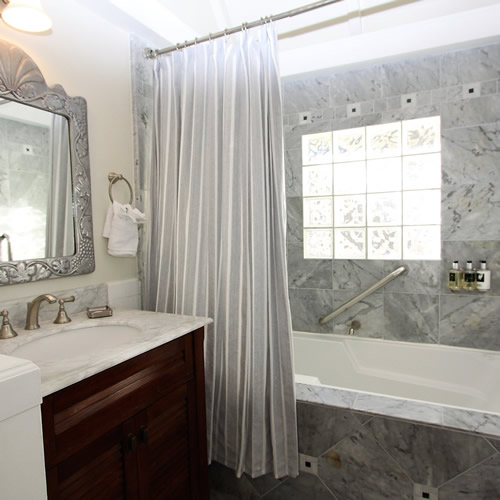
[136,383,198,500]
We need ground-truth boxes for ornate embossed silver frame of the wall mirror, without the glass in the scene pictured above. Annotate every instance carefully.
[0,40,95,286]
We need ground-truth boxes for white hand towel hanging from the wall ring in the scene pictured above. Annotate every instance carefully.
[103,201,146,257]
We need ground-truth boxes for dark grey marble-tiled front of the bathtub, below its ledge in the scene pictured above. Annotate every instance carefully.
[210,402,500,500]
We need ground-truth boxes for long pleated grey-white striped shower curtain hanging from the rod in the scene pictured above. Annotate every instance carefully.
[146,25,298,477]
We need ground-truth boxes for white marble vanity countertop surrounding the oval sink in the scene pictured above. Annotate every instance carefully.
[0,309,212,397]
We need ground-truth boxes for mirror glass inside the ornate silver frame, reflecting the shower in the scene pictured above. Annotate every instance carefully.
[0,99,75,261]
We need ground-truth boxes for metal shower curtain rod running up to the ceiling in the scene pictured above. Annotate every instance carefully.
[145,0,343,59]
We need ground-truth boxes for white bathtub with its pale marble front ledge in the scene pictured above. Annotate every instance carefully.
[294,332,500,437]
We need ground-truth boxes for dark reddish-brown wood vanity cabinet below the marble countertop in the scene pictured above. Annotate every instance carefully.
[42,328,208,500]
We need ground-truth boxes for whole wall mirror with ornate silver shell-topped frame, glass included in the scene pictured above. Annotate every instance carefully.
[0,40,95,285]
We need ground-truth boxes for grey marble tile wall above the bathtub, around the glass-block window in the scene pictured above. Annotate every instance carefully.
[283,44,500,350]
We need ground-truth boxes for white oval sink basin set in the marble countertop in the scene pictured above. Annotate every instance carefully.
[10,325,140,364]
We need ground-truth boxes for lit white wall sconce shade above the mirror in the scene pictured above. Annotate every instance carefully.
[1,0,52,33]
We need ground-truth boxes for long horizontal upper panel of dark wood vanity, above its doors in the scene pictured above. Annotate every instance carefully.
[43,335,193,463]
